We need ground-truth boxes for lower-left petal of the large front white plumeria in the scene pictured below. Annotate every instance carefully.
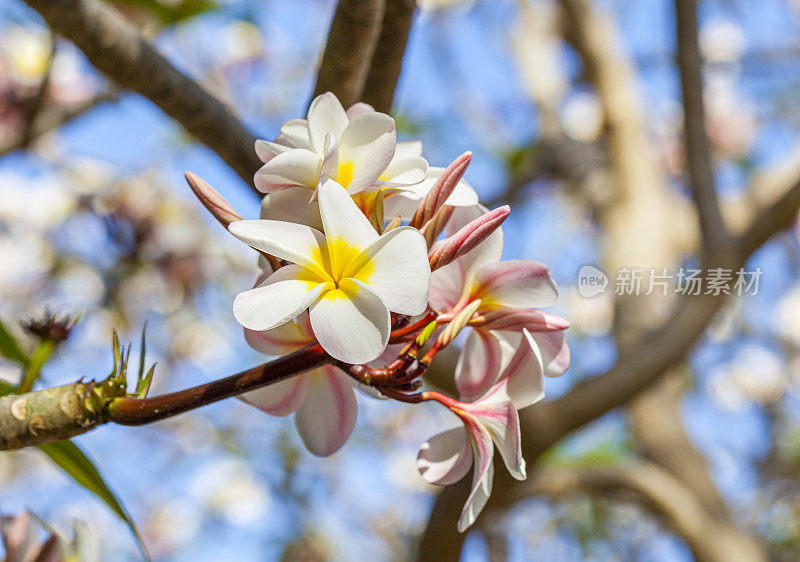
[233,265,333,331]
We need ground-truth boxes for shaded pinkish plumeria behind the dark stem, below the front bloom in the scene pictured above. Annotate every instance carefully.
[241,313,358,457]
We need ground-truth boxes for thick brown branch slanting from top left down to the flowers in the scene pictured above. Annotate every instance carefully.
[26,0,261,190]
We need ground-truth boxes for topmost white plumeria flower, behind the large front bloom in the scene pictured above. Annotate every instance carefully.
[254,92,428,195]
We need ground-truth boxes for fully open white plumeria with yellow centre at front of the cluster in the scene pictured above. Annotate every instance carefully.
[228,180,430,364]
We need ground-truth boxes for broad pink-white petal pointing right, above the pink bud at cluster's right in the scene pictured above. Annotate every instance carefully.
[473,260,558,308]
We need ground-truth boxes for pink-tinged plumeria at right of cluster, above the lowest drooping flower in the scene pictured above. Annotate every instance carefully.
[428,206,570,400]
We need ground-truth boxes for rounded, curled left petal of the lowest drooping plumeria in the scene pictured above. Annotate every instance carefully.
[417,427,472,486]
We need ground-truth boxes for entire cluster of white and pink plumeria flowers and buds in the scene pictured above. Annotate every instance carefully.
[187,93,569,531]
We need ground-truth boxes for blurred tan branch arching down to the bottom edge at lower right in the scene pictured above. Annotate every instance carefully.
[514,462,766,562]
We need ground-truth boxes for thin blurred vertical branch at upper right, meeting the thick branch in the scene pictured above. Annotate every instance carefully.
[675,0,729,254]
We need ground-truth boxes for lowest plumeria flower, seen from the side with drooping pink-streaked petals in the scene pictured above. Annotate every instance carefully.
[417,340,544,532]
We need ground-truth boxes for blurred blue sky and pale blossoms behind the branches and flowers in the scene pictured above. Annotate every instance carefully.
[0,0,800,562]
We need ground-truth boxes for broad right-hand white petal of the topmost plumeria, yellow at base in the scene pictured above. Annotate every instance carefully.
[339,113,397,194]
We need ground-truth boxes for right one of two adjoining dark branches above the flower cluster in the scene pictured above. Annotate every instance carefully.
[361,0,417,113]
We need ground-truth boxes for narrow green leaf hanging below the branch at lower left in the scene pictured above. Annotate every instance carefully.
[39,441,150,560]
